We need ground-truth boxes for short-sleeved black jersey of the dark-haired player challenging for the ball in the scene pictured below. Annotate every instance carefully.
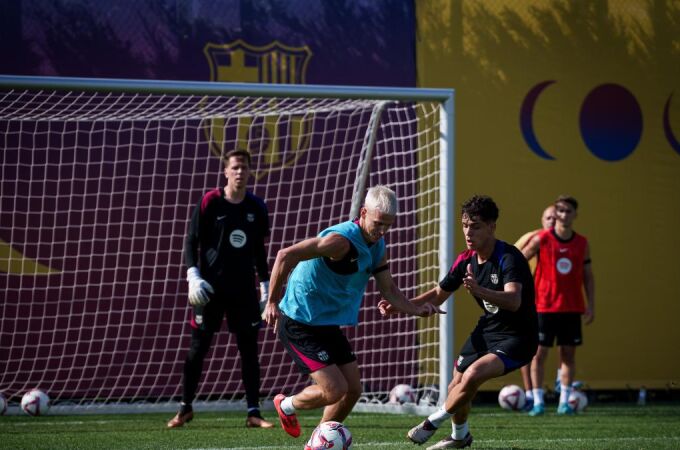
[439,240,538,338]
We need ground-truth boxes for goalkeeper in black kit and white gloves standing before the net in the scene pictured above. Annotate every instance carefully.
[168,150,273,428]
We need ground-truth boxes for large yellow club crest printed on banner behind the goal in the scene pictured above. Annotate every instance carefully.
[203,39,312,179]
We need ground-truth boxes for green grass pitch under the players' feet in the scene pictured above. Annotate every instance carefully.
[0,403,680,450]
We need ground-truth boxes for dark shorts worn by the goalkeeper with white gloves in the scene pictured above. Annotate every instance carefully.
[191,291,262,333]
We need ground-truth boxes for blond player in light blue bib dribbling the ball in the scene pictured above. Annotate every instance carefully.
[265,186,441,437]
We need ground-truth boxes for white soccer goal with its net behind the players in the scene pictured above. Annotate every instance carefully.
[0,76,455,413]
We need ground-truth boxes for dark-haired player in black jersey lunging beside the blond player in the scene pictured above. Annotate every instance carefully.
[396,196,537,450]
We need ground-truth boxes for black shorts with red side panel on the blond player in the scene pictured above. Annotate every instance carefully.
[279,314,357,374]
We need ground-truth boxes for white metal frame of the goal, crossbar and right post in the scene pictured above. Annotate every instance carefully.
[0,75,455,413]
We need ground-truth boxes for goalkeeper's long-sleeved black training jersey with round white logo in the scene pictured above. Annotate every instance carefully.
[184,189,269,292]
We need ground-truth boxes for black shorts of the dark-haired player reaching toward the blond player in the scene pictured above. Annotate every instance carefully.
[455,333,538,375]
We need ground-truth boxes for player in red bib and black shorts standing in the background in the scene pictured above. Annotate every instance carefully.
[522,196,595,416]
